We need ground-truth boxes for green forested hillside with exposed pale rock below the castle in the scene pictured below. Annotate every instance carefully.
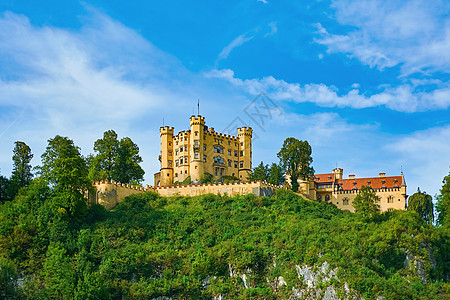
[0,186,449,299]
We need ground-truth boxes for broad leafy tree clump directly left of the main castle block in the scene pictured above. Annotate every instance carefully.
[88,130,145,183]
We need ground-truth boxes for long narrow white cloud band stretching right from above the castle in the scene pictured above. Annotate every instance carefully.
[205,69,450,112]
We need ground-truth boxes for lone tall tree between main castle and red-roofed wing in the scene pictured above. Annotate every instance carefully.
[277,137,314,192]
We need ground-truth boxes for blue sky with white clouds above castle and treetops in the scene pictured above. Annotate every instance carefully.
[0,0,450,195]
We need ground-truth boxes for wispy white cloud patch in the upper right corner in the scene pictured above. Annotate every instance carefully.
[315,0,450,74]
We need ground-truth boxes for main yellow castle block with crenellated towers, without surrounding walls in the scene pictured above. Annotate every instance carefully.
[154,115,252,186]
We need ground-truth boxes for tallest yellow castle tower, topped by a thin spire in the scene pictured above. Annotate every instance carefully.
[189,115,205,181]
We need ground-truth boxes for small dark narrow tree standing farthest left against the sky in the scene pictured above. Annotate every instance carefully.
[11,141,33,188]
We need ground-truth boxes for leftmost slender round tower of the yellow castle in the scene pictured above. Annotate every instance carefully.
[159,126,174,186]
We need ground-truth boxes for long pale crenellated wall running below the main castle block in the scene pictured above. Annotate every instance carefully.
[156,181,279,197]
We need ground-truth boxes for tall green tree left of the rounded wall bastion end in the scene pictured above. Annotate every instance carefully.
[40,135,92,219]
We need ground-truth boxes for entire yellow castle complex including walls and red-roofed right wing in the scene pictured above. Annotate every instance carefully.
[90,115,408,212]
